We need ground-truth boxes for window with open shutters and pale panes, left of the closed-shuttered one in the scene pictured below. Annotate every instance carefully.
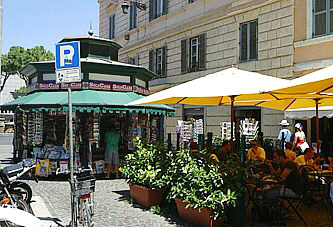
[181,33,206,73]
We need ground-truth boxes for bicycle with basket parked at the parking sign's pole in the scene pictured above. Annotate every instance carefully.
[56,167,96,227]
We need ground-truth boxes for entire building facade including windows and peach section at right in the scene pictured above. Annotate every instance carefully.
[99,0,333,145]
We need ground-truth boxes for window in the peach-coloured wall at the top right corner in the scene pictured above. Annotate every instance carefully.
[313,0,333,36]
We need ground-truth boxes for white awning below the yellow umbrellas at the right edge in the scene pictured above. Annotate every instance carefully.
[284,106,333,118]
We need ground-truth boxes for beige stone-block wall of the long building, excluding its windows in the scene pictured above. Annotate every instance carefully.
[100,0,295,144]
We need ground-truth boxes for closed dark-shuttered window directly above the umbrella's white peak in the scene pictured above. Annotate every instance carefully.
[239,20,258,62]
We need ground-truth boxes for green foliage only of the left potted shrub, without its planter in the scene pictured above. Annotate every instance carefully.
[120,140,168,188]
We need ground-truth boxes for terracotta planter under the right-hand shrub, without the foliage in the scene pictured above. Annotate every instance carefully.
[176,199,223,227]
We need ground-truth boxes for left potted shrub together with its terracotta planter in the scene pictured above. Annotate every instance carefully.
[120,137,168,208]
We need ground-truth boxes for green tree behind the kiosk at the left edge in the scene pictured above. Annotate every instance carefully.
[0,46,54,92]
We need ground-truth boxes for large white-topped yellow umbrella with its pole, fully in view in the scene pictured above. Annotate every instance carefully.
[128,67,289,139]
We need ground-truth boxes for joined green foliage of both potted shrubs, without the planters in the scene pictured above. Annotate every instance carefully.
[121,141,242,218]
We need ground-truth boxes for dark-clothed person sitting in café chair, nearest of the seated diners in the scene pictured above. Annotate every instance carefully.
[265,149,303,199]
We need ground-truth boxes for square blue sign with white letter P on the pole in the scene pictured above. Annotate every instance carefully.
[55,42,80,70]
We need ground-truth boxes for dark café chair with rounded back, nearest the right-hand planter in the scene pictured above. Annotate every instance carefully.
[252,174,285,226]
